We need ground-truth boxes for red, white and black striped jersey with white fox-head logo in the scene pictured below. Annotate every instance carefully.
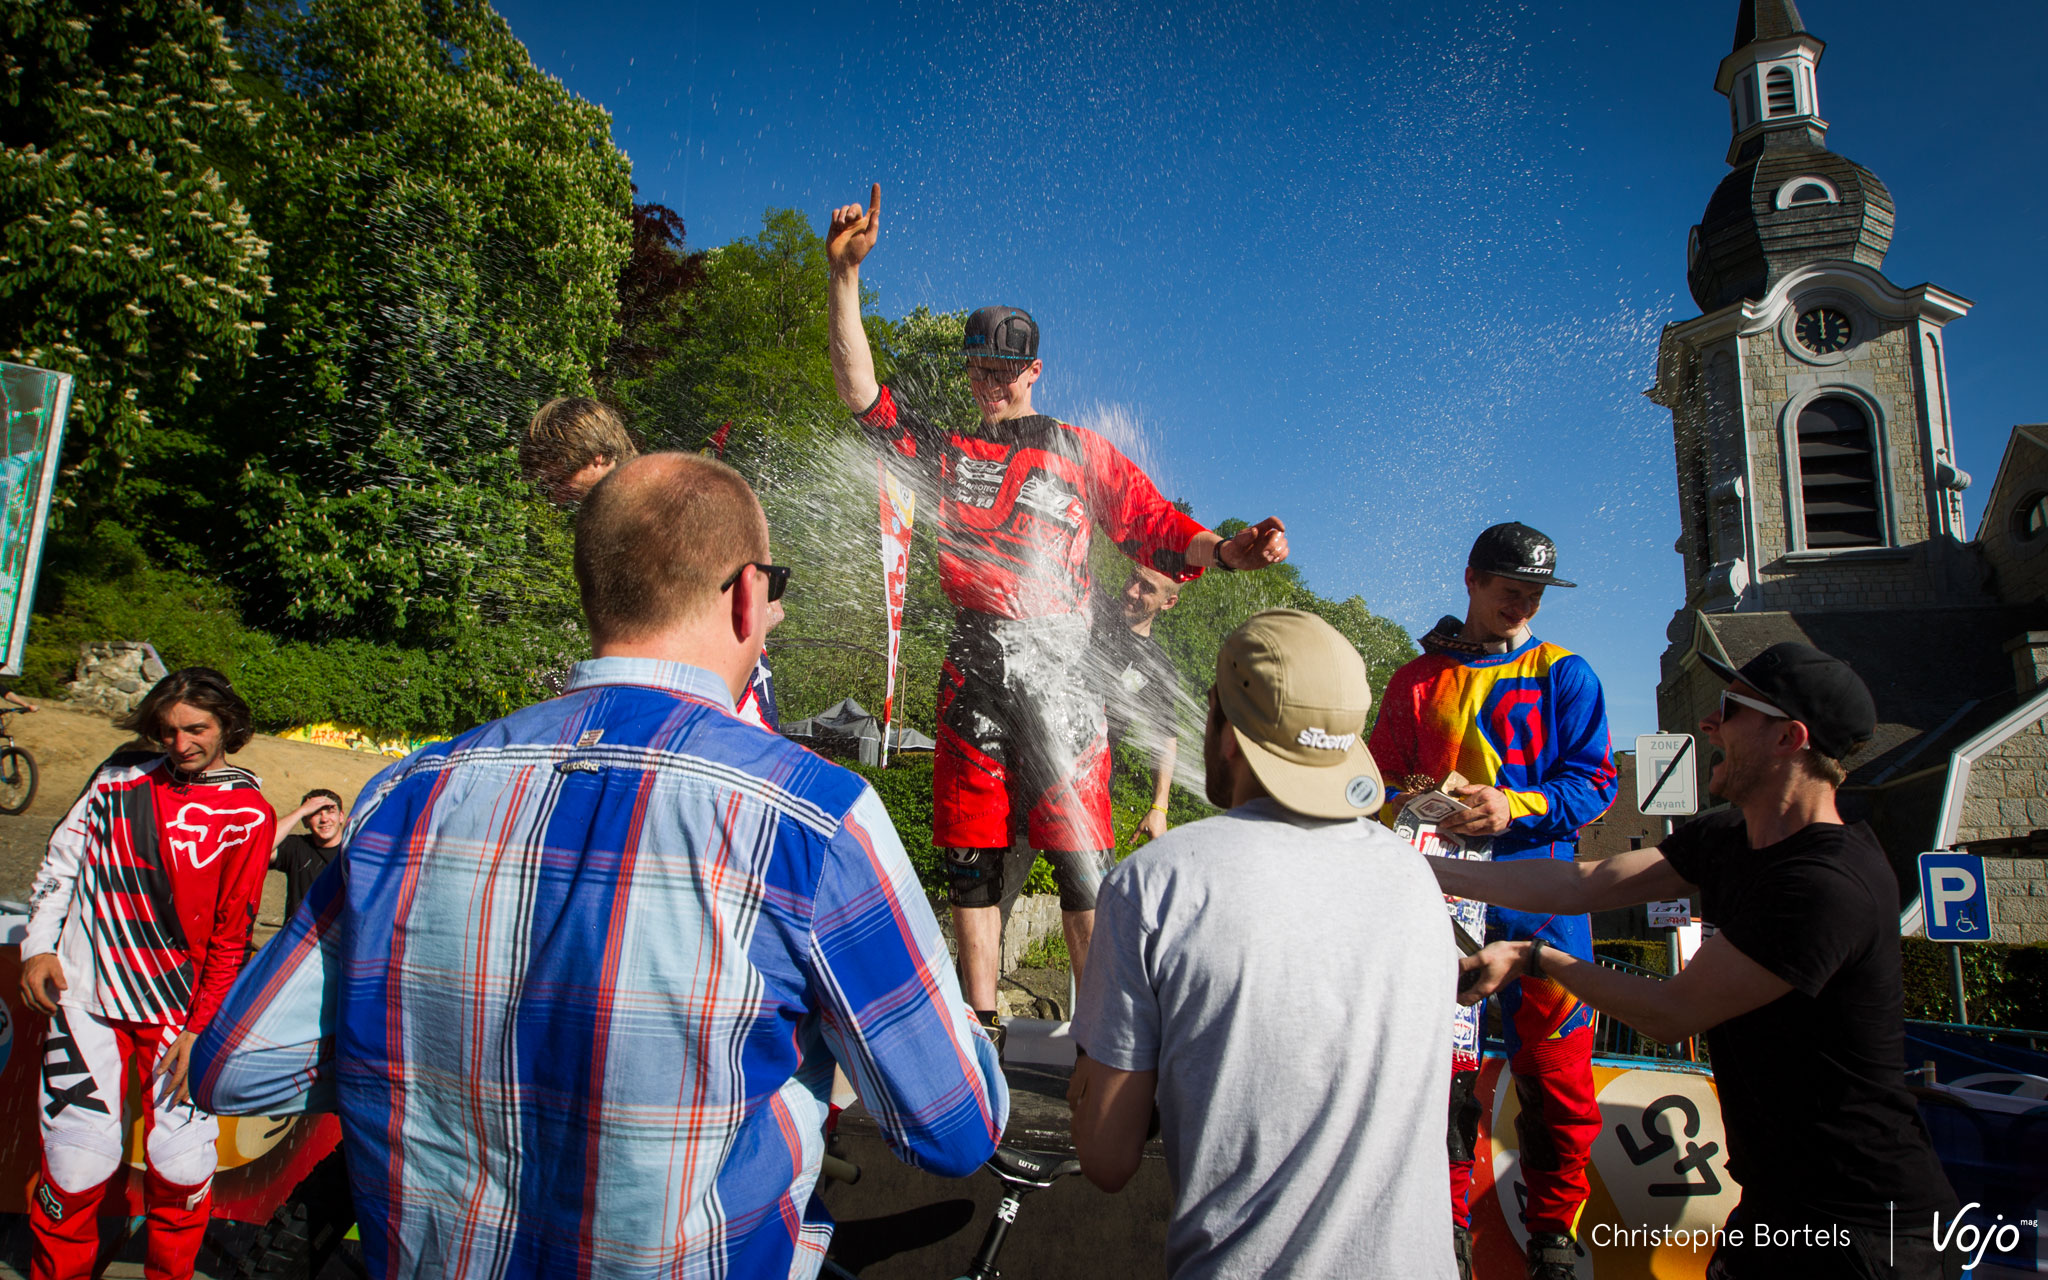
[20,752,276,1032]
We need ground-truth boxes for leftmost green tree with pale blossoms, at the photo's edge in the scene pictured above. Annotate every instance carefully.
[0,0,270,522]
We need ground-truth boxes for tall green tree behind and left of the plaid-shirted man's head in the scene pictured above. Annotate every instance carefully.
[217,0,631,643]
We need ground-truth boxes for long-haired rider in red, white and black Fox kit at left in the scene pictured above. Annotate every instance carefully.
[20,668,276,1280]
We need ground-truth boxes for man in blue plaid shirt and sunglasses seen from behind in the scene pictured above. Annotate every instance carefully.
[193,455,1010,1278]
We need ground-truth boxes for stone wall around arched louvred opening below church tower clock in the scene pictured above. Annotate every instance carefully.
[1743,313,1944,608]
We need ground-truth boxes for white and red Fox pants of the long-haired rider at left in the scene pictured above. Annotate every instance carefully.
[29,1008,221,1280]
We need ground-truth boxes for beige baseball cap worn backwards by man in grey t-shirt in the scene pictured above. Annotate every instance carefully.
[1217,608,1386,817]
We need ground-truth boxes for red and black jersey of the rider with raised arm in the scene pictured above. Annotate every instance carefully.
[860,387,1202,618]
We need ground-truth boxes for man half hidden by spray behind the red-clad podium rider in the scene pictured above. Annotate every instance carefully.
[1092,565,1180,840]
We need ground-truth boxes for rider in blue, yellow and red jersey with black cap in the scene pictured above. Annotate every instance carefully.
[1372,524,1616,1280]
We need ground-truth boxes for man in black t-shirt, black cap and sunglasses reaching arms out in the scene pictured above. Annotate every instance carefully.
[1432,643,1962,1280]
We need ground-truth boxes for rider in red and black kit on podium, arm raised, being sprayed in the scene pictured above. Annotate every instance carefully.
[825,182,1286,1040]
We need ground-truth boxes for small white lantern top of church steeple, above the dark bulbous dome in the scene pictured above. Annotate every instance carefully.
[1714,0,1827,164]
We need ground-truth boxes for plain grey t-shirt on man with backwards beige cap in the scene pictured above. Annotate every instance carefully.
[1073,799,1458,1280]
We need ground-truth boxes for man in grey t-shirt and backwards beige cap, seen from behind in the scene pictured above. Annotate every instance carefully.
[1067,608,1458,1280]
